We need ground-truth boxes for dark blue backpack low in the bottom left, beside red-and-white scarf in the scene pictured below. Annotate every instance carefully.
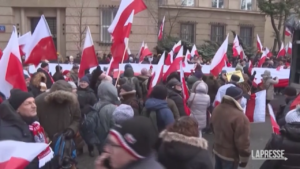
[52,133,77,169]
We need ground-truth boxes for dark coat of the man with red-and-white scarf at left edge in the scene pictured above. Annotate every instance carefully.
[0,101,39,169]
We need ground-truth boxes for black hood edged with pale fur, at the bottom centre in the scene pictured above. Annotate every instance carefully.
[159,130,208,163]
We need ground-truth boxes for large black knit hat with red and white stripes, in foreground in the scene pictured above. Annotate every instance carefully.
[109,116,158,159]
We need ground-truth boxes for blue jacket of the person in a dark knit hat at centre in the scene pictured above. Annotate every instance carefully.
[145,98,175,131]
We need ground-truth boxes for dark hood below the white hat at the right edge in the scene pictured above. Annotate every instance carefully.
[280,123,300,142]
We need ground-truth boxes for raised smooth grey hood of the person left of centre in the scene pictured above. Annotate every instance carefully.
[97,82,120,104]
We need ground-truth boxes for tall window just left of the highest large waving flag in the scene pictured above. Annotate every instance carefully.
[100,8,117,43]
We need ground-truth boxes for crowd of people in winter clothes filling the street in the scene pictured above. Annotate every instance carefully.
[0,51,300,169]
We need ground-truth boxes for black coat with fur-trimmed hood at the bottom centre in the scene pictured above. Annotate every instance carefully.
[158,130,213,169]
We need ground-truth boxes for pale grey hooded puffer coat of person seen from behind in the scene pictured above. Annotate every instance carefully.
[188,81,210,130]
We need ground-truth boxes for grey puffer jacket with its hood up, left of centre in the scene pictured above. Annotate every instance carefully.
[81,82,120,150]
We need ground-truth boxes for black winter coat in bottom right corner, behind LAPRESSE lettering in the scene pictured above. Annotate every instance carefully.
[260,123,300,169]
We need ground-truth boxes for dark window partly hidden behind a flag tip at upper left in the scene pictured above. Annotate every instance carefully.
[30,17,57,49]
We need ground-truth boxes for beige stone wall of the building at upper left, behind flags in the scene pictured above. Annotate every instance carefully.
[0,0,158,57]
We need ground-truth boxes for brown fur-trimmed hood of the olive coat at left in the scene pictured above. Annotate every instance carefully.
[44,80,78,104]
